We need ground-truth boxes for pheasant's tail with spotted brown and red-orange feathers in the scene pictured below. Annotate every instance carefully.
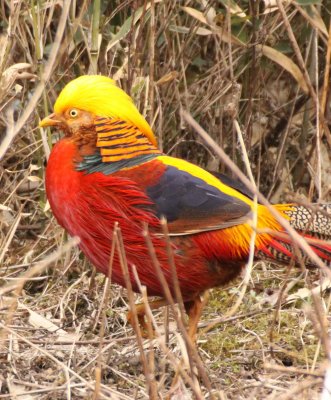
[257,203,331,267]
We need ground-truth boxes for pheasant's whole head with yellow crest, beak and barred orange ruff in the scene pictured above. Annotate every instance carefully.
[39,75,157,162]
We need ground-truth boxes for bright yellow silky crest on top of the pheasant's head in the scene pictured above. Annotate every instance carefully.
[54,75,157,146]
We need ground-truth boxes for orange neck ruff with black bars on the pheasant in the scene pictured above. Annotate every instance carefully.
[95,117,161,163]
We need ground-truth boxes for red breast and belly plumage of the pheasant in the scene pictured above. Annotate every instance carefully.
[46,139,331,300]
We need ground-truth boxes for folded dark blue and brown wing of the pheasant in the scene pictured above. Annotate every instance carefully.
[146,166,251,234]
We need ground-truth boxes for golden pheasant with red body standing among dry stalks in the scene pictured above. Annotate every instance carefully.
[40,76,331,338]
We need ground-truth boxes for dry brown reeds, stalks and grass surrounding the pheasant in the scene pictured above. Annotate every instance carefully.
[0,0,331,400]
